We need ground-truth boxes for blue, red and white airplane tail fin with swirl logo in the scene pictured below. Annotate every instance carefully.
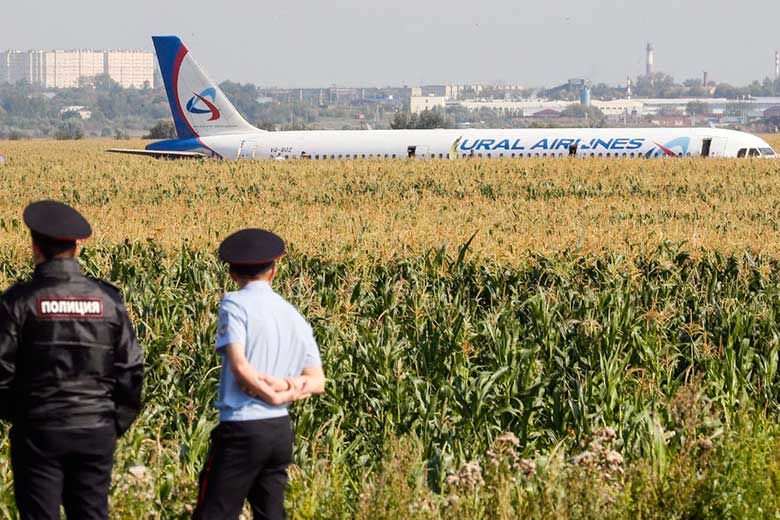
[152,36,261,139]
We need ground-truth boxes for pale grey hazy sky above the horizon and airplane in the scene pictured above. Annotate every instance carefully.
[0,0,780,87]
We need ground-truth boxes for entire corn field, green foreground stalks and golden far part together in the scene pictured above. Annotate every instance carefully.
[0,143,780,519]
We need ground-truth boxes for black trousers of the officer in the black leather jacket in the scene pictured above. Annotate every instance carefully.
[11,425,116,520]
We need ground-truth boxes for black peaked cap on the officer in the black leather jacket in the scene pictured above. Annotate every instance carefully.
[23,200,92,240]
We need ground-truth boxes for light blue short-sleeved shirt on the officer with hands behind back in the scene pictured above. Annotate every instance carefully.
[215,281,322,421]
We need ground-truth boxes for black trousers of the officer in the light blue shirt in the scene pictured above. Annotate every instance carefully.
[193,416,293,520]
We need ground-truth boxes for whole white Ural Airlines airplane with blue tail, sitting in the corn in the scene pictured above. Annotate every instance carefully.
[108,36,777,160]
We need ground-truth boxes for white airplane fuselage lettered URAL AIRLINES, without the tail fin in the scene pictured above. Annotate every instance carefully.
[149,128,774,159]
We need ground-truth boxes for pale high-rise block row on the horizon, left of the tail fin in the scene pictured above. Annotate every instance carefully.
[0,50,155,88]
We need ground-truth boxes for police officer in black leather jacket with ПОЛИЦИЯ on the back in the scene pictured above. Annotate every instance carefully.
[0,201,143,520]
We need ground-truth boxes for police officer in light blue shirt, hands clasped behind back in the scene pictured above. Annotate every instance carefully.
[194,229,325,520]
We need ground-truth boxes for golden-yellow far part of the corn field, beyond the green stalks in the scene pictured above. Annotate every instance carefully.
[0,139,780,264]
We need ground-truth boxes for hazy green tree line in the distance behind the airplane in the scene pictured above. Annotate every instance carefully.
[0,72,780,139]
